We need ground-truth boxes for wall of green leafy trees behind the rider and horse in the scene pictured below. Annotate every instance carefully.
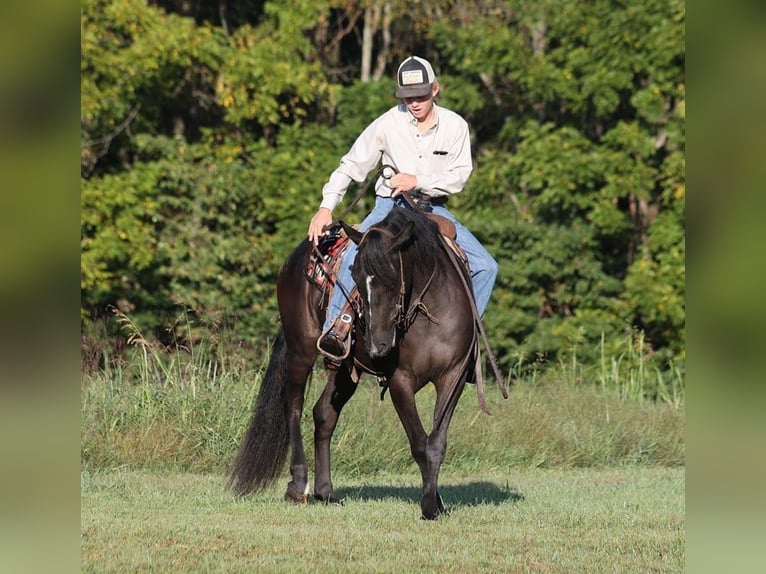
[81,0,685,374]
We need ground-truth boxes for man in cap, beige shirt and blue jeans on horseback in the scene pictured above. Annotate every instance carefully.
[308,56,497,357]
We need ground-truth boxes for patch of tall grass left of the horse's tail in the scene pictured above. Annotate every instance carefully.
[81,312,264,471]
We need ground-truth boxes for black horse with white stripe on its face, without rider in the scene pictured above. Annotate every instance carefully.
[229,207,507,519]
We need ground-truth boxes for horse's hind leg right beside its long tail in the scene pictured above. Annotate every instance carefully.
[285,360,313,504]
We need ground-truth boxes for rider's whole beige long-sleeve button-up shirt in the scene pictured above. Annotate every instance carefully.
[320,103,473,211]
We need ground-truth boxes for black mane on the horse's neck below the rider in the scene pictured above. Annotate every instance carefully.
[357,206,442,290]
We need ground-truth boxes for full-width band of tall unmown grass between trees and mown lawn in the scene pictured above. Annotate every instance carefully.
[81,314,685,477]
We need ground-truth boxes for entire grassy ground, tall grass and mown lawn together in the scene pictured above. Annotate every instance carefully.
[80,330,686,574]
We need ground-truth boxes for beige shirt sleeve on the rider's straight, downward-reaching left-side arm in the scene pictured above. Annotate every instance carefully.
[319,118,383,211]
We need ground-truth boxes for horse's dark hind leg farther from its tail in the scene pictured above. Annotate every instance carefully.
[313,364,357,503]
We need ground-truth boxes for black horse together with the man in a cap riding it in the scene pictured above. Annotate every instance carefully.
[229,58,508,519]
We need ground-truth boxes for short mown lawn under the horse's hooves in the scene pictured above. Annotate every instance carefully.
[81,470,685,573]
